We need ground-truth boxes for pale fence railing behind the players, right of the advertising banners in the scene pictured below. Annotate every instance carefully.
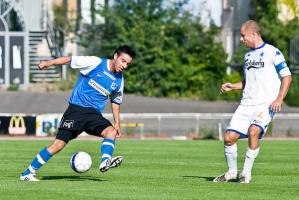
[105,113,299,139]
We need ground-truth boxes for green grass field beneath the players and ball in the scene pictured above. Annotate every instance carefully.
[0,140,299,200]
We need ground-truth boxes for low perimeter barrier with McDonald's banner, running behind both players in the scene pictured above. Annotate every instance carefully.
[0,113,299,139]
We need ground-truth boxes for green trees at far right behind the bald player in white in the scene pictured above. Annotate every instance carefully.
[233,0,299,106]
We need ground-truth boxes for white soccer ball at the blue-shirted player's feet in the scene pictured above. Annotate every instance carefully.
[70,151,92,173]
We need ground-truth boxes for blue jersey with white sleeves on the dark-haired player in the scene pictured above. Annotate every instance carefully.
[69,56,124,113]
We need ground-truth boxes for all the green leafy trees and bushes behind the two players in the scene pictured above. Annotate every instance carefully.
[58,0,299,105]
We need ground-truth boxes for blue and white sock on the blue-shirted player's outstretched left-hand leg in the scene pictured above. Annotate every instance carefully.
[22,147,52,176]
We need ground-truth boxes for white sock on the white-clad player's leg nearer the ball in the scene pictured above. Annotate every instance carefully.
[224,143,238,176]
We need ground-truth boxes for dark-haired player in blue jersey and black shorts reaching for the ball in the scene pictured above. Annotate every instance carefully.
[20,45,135,181]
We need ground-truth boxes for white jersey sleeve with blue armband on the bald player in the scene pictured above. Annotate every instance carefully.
[273,49,291,77]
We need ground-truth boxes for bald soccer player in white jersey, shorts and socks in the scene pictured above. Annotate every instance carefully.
[214,20,292,183]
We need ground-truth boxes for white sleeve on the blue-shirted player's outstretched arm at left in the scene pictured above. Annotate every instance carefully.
[70,56,102,75]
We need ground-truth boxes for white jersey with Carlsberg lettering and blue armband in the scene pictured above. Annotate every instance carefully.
[241,43,291,106]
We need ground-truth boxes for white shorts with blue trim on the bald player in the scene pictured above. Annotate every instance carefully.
[226,104,275,139]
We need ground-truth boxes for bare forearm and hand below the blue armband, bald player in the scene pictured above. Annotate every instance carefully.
[270,75,292,112]
